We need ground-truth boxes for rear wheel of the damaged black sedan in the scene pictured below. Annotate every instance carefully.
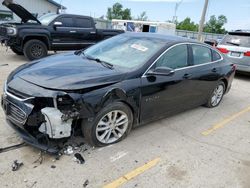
[206,81,226,108]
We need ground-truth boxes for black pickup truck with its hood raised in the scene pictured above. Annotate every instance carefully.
[0,0,124,60]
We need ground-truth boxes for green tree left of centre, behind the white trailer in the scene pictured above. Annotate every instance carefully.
[107,3,132,20]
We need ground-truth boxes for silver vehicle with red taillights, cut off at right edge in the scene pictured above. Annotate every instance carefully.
[217,30,250,73]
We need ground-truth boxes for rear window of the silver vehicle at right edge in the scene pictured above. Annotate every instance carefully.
[220,35,250,48]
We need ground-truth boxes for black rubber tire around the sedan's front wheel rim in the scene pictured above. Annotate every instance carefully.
[82,102,133,147]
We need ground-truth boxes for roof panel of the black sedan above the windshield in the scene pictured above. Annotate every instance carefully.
[124,32,199,43]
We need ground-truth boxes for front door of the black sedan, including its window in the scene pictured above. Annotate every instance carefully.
[140,44,195,123]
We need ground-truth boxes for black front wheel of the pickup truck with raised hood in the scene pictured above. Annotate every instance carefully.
[23,40,48,61]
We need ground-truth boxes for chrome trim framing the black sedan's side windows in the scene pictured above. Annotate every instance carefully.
[142,42,224,77]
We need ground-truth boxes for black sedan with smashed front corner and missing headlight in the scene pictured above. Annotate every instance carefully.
[1,33,235,152]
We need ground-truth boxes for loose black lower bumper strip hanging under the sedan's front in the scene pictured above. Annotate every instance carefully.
[6,119,60,155]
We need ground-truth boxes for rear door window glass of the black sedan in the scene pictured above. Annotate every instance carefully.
[192,45,212,65]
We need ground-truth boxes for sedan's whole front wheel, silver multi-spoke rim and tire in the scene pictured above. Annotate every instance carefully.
[82,102,133,146]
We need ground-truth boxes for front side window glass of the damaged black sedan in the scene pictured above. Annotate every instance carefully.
[156,45,188,69]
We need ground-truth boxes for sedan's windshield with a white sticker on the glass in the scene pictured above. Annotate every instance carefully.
[84,35,166,69]
